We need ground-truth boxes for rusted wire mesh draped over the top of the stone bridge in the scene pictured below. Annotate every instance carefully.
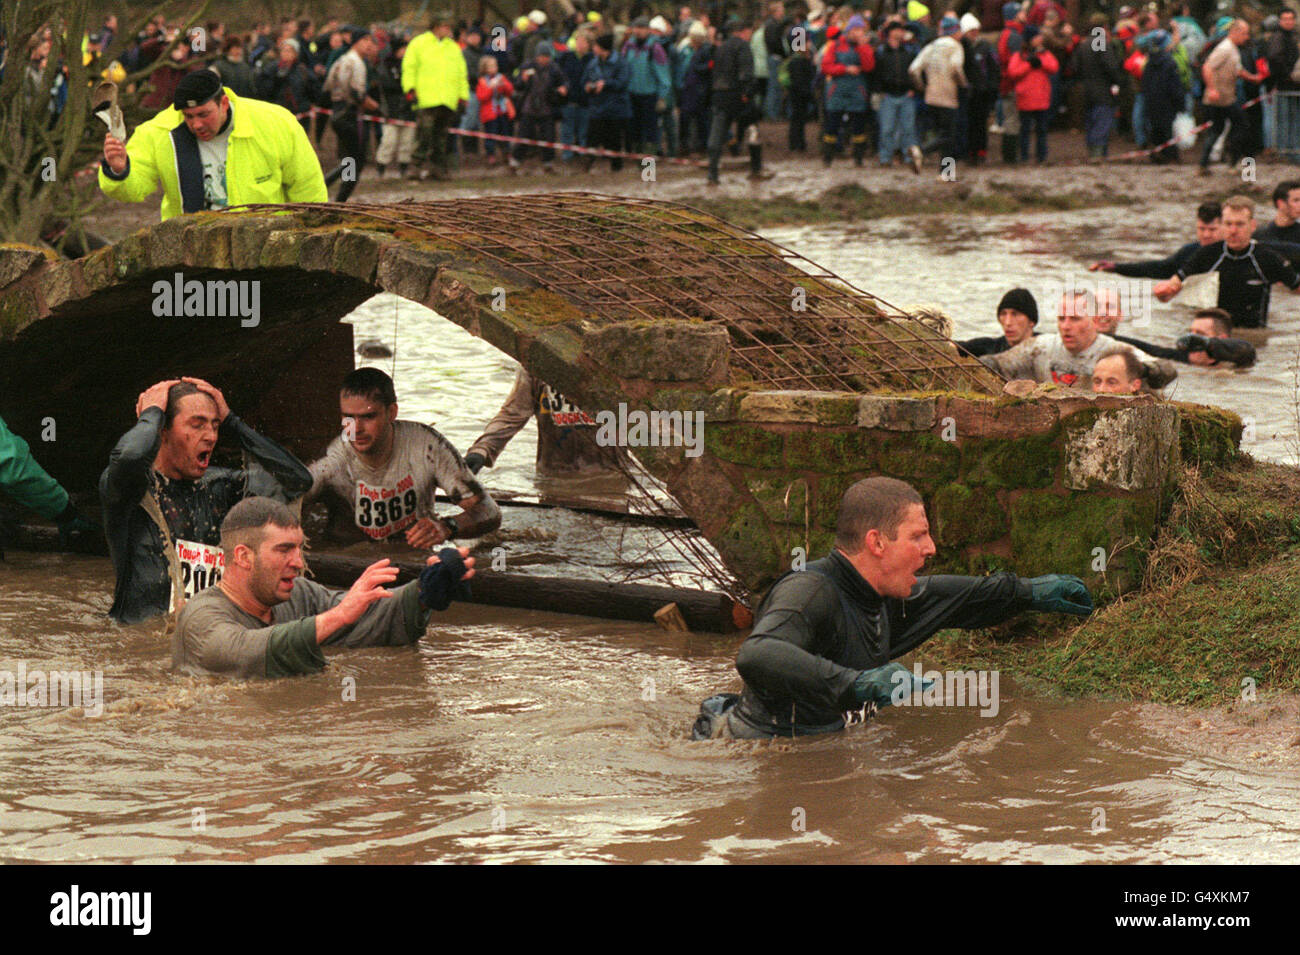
[231,192,1001,394]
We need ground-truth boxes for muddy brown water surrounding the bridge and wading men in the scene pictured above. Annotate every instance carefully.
[0,213,1300,863]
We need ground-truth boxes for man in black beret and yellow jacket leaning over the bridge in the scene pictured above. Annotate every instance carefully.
[99,70,329,220]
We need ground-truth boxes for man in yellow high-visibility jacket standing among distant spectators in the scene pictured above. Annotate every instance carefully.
[402,13,469,179]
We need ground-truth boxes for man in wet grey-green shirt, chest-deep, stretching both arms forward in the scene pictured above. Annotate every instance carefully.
[172,498,475,678]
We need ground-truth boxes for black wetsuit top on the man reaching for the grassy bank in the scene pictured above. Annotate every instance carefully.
[733,551,1031,737]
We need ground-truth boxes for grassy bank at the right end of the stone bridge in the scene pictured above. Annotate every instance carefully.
[919,457,1300,706]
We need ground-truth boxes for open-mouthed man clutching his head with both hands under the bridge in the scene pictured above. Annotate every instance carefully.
[99,378,312,624]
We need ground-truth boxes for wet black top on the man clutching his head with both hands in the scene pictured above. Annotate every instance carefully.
[99,408,312,624]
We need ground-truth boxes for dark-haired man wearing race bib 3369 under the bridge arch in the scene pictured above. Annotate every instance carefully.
[303,368,501,550]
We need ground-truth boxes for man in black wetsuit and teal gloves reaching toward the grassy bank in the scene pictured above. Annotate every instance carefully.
[692,477,1092,739]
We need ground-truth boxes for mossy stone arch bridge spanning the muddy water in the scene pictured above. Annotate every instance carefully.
[0,194,1240,592]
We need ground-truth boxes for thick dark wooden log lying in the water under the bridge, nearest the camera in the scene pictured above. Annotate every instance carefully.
[308,551,744,633]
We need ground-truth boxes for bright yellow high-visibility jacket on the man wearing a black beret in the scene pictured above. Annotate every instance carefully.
[99,87,329,220]
